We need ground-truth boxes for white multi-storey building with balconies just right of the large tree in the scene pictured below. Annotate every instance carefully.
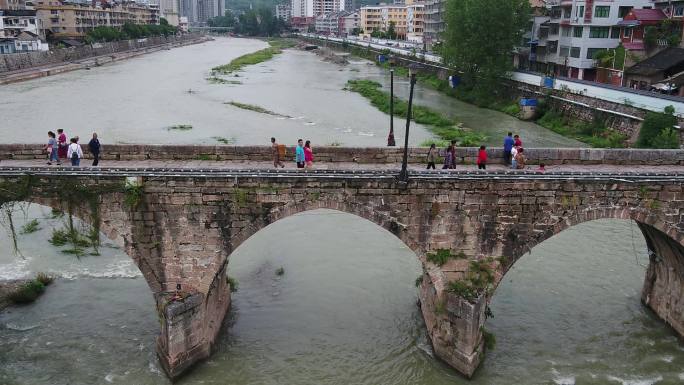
[529,0,653,80]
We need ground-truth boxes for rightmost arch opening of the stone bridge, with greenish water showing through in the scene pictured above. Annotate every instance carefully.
[481,219,684,383]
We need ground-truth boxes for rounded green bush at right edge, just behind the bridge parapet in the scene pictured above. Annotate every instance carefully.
[636,106,679,148]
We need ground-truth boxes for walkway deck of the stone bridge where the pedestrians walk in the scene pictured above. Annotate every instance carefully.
[0,159,684,180]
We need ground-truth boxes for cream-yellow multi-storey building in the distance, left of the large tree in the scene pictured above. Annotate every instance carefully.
[359,0,424,41]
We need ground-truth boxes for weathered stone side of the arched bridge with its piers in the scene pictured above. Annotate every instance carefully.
[0,167,684,377]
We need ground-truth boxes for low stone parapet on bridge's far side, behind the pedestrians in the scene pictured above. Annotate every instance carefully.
[0,144,684,166]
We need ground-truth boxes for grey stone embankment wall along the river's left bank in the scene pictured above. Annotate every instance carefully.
[0,34,206,74]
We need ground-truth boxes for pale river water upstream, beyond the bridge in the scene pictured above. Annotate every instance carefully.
[0,38,582,147]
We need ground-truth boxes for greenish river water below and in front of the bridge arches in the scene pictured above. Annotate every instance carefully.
[0,210,684,385]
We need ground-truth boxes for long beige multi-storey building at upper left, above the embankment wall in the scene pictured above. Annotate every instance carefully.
[35,0,159,39]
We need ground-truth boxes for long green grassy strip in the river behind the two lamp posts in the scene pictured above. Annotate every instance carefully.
[346,80,485,146]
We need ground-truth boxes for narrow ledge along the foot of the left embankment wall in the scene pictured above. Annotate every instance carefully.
[0,36,212,85]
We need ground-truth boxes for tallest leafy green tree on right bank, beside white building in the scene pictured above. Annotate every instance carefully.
[441,0,531,104]
